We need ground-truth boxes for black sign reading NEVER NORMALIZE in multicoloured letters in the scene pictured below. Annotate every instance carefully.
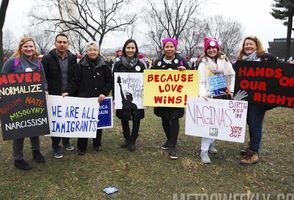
[0,72,49,140]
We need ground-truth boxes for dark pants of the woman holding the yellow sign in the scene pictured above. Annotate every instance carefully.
[161,118,180,147]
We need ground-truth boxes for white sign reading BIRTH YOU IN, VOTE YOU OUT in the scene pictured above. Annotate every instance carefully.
[185,97,248,143]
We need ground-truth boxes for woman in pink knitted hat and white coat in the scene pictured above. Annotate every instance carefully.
[198,37,235,164]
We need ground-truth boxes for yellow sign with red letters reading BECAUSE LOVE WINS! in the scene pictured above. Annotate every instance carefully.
[144,70,199,108]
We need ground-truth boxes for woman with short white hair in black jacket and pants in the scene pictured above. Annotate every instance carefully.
[68,41,112,155]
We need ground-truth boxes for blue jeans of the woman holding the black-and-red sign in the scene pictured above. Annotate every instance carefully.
[247,103,266,152]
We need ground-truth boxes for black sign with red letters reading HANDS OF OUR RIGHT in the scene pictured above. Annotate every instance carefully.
[234,61,294,108]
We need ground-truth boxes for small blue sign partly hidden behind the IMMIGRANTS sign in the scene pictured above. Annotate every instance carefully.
[98,97,113,129]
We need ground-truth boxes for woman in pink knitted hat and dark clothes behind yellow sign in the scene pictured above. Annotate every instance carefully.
[152,38,189,160]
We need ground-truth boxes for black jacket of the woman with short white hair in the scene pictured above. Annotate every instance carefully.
[68,55,112,97]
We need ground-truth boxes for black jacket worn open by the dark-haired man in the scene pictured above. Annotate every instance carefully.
[42,49,77,95]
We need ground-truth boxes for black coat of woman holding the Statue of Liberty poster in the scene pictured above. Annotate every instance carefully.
[112,57,145,120]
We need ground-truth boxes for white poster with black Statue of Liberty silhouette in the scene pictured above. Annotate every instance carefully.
[114,73,144,109]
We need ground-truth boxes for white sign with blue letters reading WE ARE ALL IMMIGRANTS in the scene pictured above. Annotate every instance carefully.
[47,95,99,138]
